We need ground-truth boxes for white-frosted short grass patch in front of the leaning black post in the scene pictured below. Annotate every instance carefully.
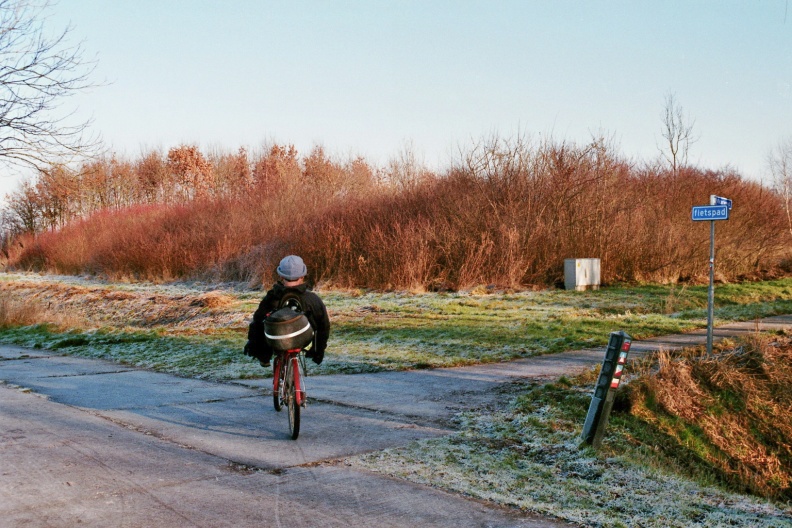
[347,392,792,528]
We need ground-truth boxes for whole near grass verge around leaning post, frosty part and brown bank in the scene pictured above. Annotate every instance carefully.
[346,337,792,528]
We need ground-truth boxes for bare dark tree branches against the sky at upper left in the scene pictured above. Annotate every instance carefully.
[0,0,97,168]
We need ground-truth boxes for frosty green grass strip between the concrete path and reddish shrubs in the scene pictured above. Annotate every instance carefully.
[0,274,792,380]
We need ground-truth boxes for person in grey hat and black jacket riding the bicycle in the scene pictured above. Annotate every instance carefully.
[245,255,330,368]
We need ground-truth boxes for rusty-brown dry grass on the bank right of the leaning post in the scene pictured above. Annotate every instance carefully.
[629,334,792,501]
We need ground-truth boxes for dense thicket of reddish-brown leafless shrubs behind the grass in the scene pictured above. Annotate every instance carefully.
[6,138,792,289]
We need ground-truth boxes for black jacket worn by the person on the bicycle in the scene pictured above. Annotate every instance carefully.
[248,282,330,358]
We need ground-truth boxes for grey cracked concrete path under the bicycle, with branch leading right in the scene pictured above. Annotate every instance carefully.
[0,316,792,527]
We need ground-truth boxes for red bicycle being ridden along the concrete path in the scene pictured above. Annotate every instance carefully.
[272,348,307,440]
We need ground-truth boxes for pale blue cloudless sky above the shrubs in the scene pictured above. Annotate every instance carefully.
[29,0,792,187]
